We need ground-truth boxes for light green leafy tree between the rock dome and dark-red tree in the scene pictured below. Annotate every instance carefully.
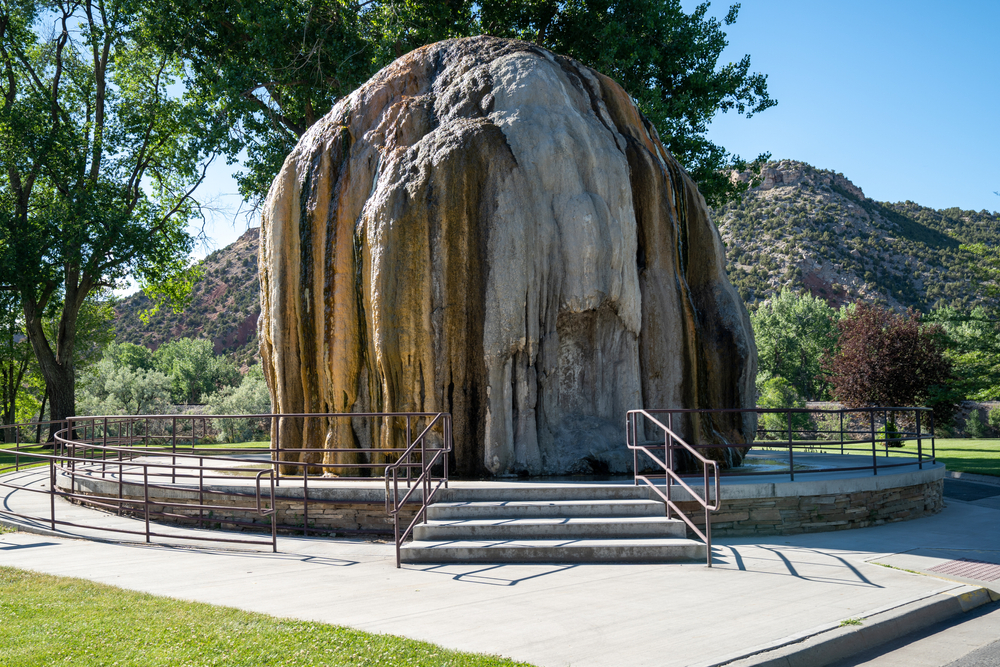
[750,288,837,407]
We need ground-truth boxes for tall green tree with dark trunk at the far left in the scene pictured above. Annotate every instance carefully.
[0,0,220,428]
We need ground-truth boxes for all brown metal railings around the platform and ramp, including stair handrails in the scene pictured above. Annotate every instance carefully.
[0,408,936,566]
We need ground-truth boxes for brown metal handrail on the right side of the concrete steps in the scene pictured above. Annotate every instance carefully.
[625,410,720,567]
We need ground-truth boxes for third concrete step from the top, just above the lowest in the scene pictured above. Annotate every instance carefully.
[413,516,687,541]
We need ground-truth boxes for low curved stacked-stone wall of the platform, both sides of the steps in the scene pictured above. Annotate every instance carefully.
[58,464,945,537]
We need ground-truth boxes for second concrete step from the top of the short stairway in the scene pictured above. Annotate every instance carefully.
[427,500,666,521]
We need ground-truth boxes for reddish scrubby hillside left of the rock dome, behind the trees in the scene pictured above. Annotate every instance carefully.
[115,228,260,364]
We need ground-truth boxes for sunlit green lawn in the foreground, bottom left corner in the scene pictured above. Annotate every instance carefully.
[0,567,526,667]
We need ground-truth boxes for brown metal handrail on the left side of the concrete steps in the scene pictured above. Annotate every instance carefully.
[385,412,452,568]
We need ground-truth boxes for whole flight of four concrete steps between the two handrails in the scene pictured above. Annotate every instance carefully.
[401,485,706,563]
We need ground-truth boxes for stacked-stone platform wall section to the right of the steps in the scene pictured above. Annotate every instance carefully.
[678,479,944,537]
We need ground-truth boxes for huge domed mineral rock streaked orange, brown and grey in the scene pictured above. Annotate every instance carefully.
[259,37,756,476]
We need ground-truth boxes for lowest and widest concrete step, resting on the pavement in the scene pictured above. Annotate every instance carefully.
[400,537,706,563]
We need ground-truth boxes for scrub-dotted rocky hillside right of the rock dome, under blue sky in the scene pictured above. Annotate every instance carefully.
[713,160,1000,311]
